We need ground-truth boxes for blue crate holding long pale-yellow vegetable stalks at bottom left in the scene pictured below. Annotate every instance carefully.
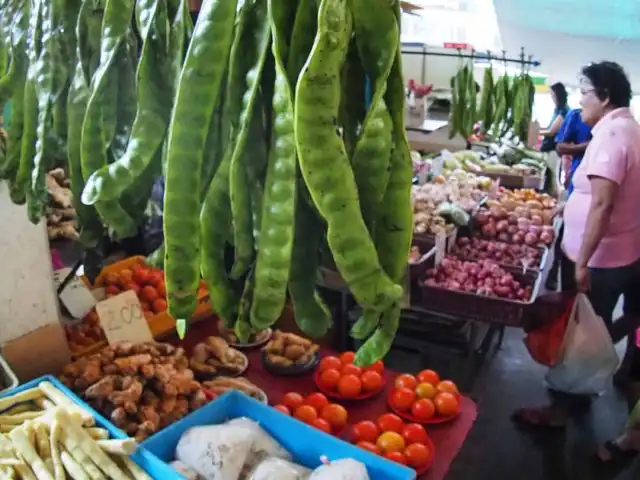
[0,375,176,479]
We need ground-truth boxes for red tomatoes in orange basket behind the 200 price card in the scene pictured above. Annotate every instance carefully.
[98,263,167,319]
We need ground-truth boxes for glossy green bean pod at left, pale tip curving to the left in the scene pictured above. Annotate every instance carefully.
[82,0,172,205]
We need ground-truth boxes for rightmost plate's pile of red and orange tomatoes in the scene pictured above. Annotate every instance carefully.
[389,370,460,422]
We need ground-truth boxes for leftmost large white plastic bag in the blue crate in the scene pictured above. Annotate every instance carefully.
[176,425,256,480]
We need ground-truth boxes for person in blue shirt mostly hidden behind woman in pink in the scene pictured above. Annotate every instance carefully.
[546,108,591,291]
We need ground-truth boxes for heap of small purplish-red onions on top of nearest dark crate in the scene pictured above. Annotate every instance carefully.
[424,256,533,302]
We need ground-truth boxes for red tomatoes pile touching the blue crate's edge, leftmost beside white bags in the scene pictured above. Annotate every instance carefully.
[273,392,349,436]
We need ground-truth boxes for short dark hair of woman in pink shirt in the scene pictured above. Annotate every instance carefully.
[582,62,632,108]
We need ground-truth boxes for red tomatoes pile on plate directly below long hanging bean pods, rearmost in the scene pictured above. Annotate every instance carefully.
[315,352,384,400]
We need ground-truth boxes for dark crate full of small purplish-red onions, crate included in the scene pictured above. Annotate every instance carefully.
[420,256,542,327]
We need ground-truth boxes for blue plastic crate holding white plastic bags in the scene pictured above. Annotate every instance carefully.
[142,391,416,480]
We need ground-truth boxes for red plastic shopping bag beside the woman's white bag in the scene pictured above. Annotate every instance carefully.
[524,296,576,367]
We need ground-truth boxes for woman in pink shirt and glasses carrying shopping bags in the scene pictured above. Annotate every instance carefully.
[514,62,640,427]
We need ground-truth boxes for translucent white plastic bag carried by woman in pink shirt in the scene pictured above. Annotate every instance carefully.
[546,294,619,395]
